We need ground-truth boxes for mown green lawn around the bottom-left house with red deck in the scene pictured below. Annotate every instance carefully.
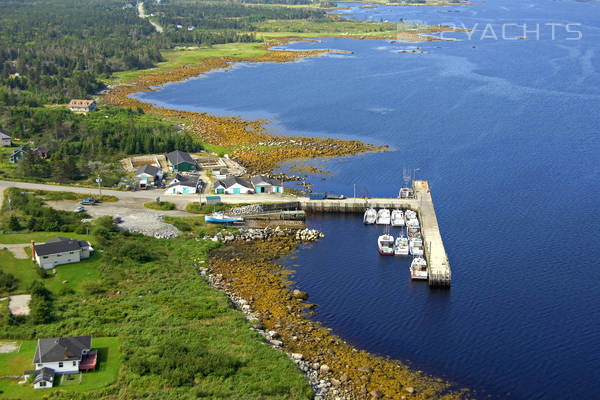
[0,337,121,399]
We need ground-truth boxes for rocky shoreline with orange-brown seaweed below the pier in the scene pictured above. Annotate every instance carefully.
[202,233,469,400]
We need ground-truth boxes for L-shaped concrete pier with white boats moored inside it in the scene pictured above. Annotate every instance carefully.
[299,181,452,287]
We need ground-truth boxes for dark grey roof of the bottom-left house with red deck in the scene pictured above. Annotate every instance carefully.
[33,336,92,364]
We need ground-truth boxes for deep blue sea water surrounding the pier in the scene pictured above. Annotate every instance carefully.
[139,0,600,399]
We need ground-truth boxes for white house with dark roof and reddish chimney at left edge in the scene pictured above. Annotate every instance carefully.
[31,236,94,269]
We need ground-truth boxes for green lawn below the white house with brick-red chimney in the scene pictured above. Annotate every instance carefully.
[0,245,102,295]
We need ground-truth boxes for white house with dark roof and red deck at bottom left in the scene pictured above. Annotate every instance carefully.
[25,336,98,389]
